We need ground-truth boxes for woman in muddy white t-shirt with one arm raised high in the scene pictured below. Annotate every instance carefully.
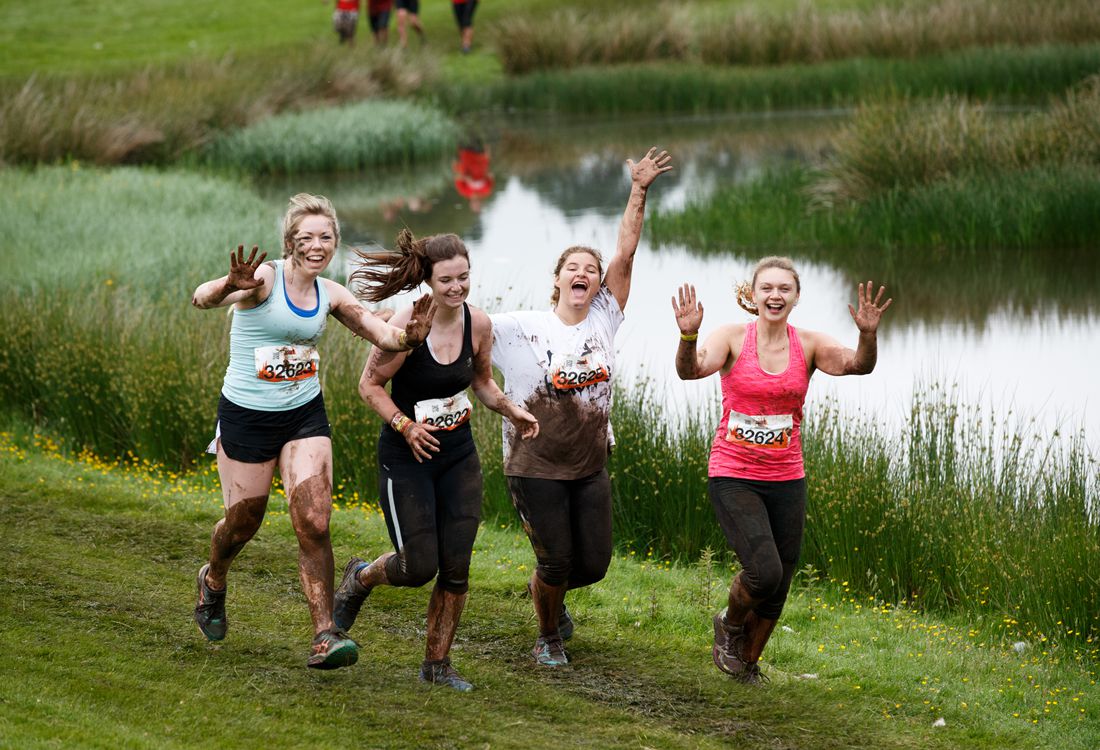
[492,148,672,666]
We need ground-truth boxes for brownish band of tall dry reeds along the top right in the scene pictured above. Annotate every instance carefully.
[493,0,1100,75]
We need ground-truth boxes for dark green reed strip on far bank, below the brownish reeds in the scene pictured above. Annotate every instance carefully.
[432,44,1100,115]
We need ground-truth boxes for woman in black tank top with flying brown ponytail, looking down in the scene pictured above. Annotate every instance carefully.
[332,230,539,691]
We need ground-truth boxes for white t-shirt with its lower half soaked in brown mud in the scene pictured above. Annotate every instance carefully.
[491,286,624,479]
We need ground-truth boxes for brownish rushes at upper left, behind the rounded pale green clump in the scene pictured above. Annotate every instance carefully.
[0,44,436,164]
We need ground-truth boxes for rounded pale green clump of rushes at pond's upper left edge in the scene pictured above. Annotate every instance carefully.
[206,99,459,174]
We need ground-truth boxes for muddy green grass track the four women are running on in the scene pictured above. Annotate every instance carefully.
[0,434,1100,749]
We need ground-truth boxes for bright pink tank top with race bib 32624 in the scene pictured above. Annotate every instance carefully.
[707,321,810,482]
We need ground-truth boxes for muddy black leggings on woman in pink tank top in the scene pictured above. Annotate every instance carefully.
[707,476,806,620]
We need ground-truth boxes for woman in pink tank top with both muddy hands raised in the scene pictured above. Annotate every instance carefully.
[672,256,893,684]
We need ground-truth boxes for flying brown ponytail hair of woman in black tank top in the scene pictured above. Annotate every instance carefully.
[350,229,470,302]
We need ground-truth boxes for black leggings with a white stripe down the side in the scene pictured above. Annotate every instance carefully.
[378,435,482,594]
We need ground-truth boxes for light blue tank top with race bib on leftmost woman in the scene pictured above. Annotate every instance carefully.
[221,261,329,411]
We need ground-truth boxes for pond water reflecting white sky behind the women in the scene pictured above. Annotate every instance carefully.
[262,112,1100,446]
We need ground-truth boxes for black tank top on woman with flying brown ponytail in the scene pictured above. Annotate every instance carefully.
[382,302,474,452]
